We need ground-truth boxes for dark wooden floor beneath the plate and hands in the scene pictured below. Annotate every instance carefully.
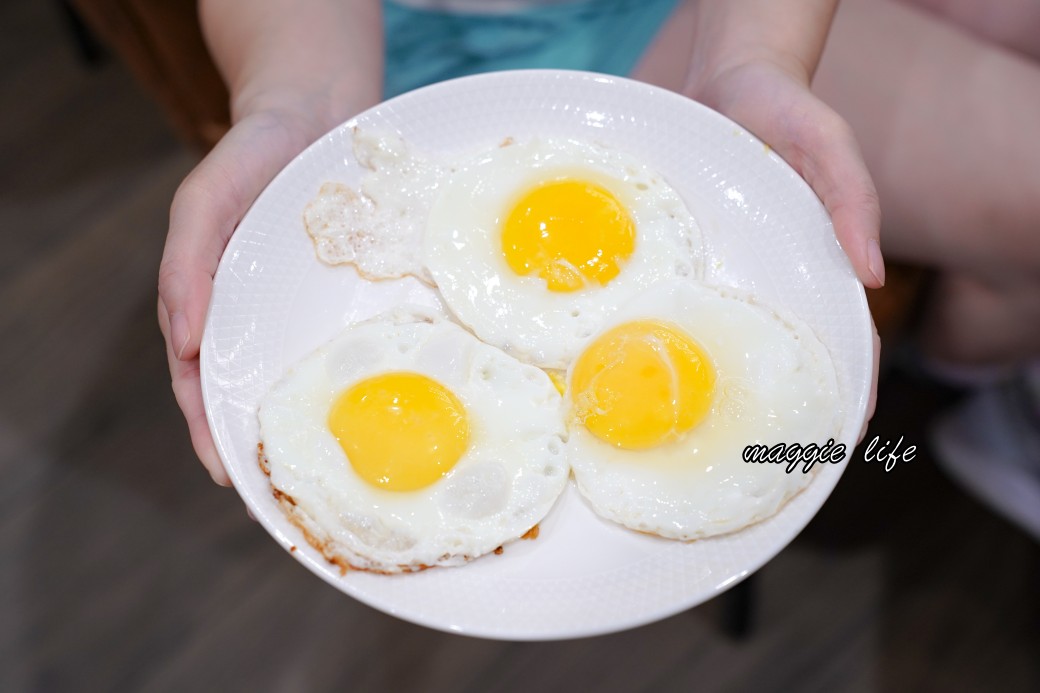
[0,0,1040,692]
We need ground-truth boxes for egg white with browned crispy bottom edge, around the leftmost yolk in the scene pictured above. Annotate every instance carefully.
[259,313,569,572]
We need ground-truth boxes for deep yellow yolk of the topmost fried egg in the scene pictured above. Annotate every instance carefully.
[502,180,635,291]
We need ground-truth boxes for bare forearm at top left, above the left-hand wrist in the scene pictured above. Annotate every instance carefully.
[200,0,383,131]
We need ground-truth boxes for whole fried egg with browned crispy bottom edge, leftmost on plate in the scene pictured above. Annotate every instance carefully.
[259,311,569,573]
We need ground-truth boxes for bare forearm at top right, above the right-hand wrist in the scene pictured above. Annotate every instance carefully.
[687,0,837,91]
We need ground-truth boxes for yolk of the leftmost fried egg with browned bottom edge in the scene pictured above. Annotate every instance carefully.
[329,373,469,491]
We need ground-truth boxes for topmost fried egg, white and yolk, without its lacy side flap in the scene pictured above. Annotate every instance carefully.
[423,134,702,368]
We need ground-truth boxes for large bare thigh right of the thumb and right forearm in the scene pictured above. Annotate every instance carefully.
[813,0,1040,279]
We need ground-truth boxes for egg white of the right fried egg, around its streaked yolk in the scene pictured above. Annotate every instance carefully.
[568,282,841,540]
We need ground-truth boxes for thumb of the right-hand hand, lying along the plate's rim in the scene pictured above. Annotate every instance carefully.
[781,102,885,288]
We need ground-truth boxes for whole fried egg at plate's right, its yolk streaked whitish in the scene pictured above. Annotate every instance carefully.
[567,281,841,540]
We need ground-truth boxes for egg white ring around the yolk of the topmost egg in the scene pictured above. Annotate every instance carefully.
[423,139,703,368]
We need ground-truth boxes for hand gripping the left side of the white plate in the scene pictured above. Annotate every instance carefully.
[158,109,332,486]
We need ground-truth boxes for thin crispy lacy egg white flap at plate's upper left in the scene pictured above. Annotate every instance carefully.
[304,128,447,284]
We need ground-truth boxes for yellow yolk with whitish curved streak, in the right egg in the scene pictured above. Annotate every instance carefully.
[571,320,716,450]
